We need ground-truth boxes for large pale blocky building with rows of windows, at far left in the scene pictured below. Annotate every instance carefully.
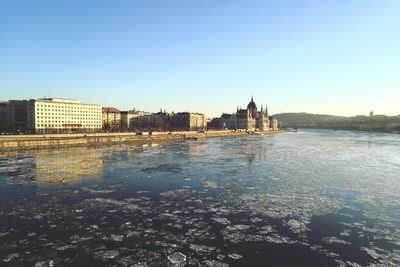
[2,98,102,133]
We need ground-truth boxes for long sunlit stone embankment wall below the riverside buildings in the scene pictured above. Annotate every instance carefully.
[0,130,286,152]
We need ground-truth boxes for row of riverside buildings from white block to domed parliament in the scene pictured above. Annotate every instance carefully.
[0,98,278,134]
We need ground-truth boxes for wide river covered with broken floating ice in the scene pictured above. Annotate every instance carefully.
[0,130,400,266]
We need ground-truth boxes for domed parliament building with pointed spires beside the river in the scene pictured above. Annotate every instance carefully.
[220,97,278,131]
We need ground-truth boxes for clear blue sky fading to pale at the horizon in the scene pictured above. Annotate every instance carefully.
[0,0,400,116]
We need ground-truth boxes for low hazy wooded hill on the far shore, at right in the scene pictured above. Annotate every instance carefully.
[274,113,400,132]
